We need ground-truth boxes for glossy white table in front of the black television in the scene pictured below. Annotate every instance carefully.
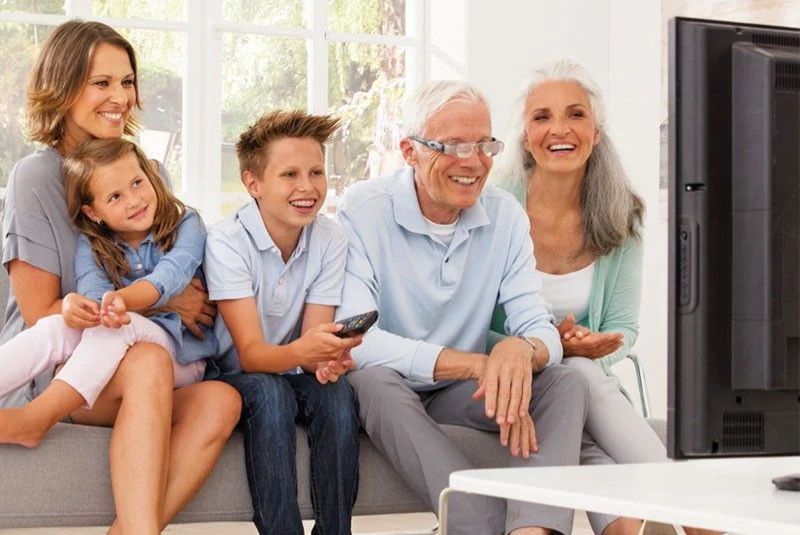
[439,457,800,535]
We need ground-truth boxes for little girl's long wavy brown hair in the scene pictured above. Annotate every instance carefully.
[63,138,186,289]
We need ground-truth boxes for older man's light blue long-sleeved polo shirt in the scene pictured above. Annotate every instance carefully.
[336,167,562,390]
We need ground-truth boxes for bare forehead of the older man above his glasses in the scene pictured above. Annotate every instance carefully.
[423,98,492,141]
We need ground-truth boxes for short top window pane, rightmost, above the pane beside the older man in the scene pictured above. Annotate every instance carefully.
[329,0,410,35]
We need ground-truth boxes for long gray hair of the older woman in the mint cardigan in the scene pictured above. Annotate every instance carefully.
[492,59,645,256]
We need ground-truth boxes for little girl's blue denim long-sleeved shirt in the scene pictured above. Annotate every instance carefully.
[75,209,214,364]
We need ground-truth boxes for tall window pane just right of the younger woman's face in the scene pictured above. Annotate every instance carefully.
[118,28,186,193]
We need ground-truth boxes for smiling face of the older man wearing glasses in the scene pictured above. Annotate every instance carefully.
[400,98,492,224]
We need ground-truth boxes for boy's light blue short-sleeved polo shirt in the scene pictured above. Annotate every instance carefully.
[205,201,347,379]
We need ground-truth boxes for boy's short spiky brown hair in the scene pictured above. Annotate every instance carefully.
[236,110,340,175]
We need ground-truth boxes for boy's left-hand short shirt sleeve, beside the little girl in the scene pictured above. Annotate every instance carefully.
[204,228,255,301]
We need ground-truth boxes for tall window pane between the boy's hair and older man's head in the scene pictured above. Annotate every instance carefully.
[328,43,405,204]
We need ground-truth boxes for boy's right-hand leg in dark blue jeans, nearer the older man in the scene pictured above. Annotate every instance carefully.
[285,373,358,535]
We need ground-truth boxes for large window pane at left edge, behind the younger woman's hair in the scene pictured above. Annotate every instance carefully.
[0,22,53,193]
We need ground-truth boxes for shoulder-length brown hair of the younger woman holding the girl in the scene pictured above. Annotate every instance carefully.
[26,20,142,145]
